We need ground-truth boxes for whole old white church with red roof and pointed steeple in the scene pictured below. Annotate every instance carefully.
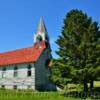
[0,18,54,90]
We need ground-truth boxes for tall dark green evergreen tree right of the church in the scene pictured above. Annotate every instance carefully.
[56,9,100,92]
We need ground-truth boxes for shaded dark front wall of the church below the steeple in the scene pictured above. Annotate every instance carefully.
[35,49,51,89]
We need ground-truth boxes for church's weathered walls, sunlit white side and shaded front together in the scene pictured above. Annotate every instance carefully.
[0,45,53,90]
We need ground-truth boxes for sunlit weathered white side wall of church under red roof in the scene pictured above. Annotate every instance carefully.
[0,63,35,89]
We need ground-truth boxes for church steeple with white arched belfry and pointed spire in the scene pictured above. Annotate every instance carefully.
[34,17,49,43]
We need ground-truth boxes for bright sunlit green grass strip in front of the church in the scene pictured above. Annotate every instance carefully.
[0,90,80,100]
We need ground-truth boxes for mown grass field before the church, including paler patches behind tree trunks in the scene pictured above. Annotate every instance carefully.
[0,81,100,100]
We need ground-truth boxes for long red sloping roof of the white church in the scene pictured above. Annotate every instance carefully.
[0,41,45,66]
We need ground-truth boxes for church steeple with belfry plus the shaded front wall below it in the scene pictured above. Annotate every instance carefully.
[34,17,55,90]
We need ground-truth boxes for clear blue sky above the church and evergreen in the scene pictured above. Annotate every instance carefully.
[0,0,100,57]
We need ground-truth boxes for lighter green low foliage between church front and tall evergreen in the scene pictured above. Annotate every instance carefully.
[51,59,72,88]
